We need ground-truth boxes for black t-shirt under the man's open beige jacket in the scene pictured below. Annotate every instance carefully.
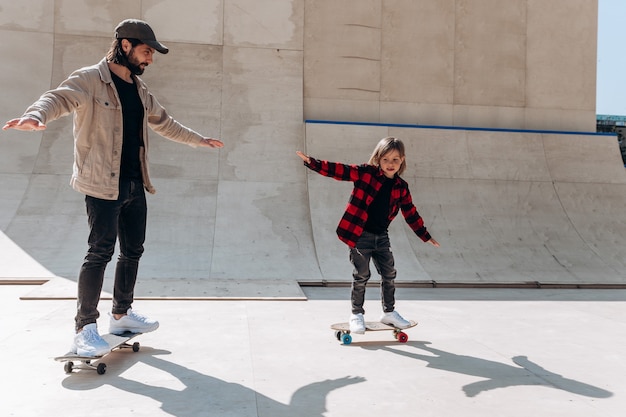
[111,73,144,179]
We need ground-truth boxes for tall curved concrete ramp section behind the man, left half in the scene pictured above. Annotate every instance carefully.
[0,1,312,299]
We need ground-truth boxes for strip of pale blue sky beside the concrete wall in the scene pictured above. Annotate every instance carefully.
[596,0,626,116]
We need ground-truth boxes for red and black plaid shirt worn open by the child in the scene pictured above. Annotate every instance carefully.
[304,158,431,248]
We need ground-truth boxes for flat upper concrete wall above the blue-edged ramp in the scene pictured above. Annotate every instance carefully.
[304,0,598,131]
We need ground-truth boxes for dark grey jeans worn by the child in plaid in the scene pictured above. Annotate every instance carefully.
[350,231,396,314]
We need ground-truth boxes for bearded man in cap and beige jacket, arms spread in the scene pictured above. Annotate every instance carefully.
[3,19,224,356]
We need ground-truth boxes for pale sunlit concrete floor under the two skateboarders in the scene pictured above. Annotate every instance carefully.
[0,285,626,417]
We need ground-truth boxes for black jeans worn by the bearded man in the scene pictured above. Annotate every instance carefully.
[76,180,147,330]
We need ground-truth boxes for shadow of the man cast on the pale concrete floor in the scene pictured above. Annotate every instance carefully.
[63,347,365,417]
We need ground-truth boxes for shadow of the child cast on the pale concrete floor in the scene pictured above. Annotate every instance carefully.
[361,342,613,398]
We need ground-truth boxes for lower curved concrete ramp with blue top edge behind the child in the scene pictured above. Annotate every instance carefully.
[306,123,626,286]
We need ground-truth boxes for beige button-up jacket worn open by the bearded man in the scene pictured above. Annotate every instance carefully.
[23,59,203,200]
